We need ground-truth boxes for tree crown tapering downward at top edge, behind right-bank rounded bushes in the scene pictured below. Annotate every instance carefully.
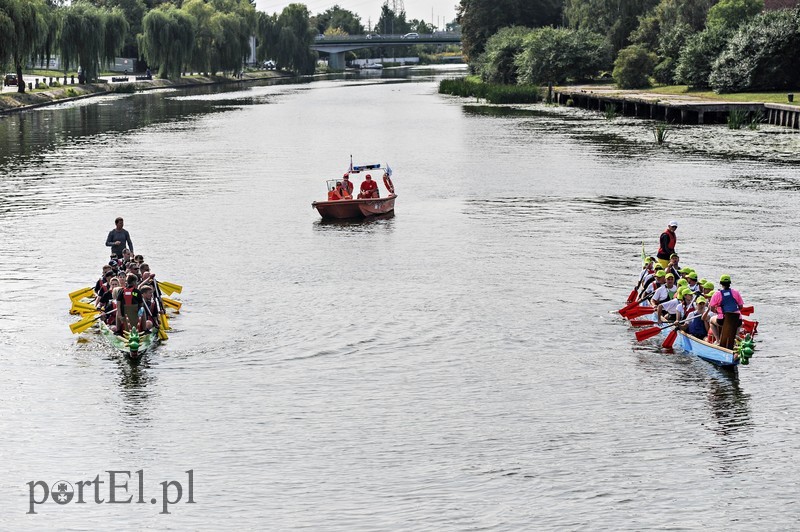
[564,0,658,53]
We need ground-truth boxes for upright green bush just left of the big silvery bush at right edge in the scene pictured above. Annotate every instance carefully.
[675,26,730,89]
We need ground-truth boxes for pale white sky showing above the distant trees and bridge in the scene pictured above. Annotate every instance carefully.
[256,0,459,30]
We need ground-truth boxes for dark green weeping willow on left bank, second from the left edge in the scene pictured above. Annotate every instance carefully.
[58,2,129,82]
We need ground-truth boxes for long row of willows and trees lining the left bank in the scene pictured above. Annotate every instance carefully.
[0,0,444,92]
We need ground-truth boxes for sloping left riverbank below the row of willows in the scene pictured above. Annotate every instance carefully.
[0,70,289,114]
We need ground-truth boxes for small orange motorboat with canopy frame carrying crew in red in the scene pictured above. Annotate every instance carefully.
[311,160,397,220]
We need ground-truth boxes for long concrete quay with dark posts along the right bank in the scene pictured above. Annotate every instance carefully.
[553,87,800,129]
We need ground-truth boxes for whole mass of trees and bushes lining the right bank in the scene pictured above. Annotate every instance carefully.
[458,0,800,92]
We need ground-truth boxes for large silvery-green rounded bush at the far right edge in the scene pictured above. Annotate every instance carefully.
[709,8,800,92]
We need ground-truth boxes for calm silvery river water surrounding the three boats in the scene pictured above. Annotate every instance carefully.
[0,67,800,531]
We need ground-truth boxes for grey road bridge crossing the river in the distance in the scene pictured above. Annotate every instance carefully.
[311,32,461,70]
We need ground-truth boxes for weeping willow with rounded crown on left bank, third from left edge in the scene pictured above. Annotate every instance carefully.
[137,4,196,78]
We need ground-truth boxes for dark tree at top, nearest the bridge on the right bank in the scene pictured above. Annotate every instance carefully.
[458,0,561,61]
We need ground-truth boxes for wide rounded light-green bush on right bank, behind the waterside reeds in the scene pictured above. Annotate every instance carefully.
[516,28,611,84]
